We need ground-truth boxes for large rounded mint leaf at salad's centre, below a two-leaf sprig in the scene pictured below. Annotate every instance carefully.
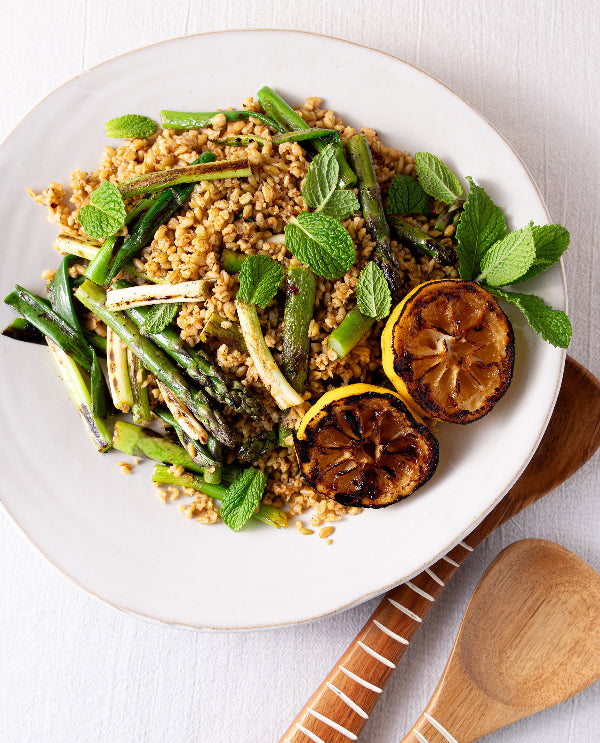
[285,212,356,279]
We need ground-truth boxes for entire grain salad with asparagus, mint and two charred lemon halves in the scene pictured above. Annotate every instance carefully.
[4,87,571,537]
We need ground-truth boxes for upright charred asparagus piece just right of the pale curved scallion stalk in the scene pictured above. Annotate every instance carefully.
[283,266,317,393]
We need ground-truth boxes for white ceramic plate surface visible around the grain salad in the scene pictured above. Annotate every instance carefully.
[0,31,566,629]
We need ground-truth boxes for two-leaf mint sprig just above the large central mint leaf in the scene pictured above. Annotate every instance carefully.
[302,144,360,219]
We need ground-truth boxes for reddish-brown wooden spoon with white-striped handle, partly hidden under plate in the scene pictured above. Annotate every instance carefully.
[281,356,600,743]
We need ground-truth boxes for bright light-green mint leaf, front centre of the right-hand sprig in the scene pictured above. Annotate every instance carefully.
[476,218,535,286]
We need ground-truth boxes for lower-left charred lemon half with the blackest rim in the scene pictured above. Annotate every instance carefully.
[294,384,438,508]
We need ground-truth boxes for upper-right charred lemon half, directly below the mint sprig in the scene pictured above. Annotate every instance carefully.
[381,279,515,423]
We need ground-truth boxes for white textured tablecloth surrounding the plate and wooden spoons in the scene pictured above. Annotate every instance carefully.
[0,0,600,743]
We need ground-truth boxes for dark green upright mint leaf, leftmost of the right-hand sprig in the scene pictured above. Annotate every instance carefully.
[456,176,506,281]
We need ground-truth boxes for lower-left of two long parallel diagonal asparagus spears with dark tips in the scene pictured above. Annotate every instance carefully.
[75,281,237,448]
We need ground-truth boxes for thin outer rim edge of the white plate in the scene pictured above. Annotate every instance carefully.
[0,28,568,632]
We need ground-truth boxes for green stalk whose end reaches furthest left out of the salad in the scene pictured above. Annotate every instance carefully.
[4,284,92,371]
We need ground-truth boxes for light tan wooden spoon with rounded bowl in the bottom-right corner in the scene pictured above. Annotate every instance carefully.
[403,539,600,743]
